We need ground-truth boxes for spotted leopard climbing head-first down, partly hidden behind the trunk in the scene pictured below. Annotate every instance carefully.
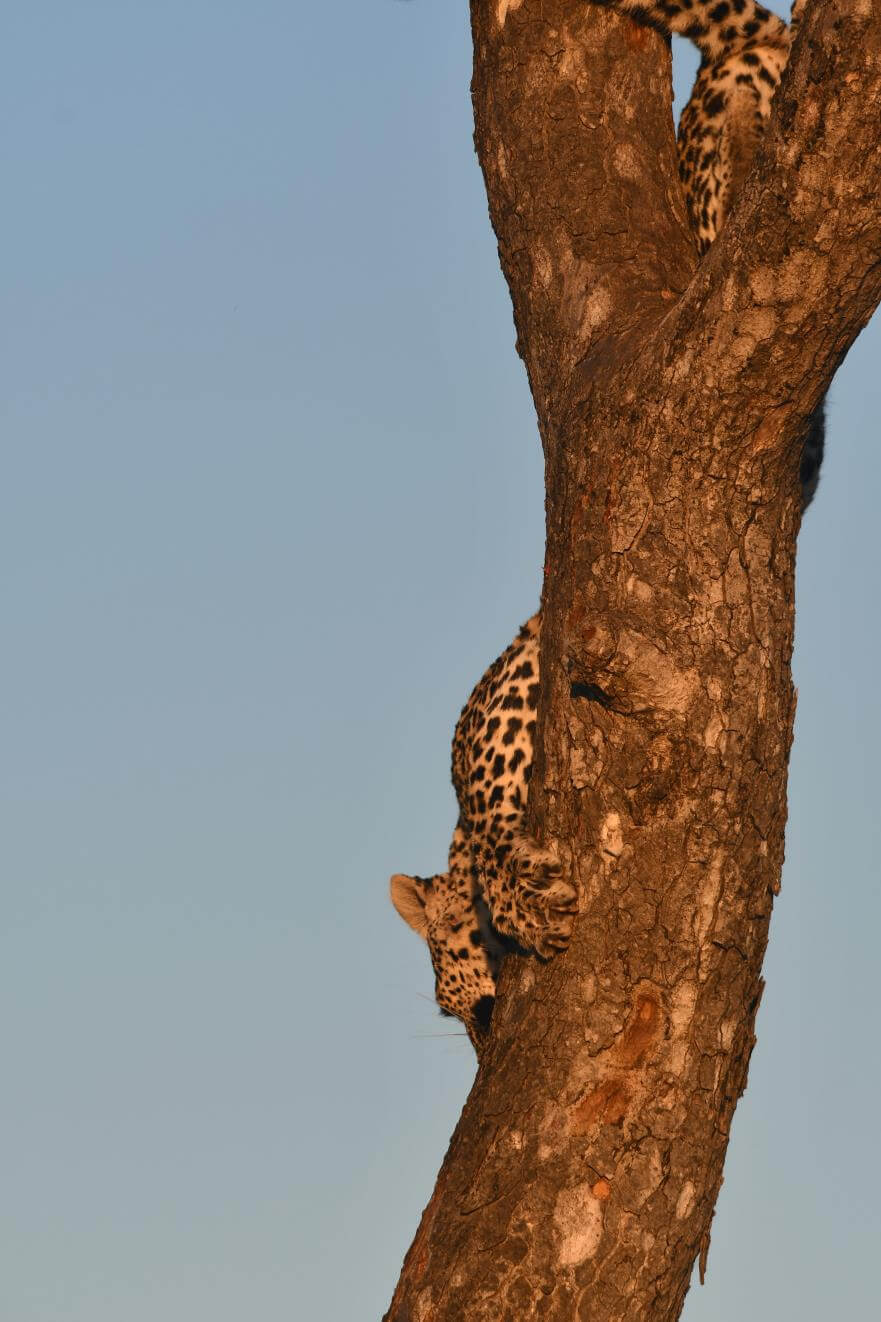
[390,0,824,1058]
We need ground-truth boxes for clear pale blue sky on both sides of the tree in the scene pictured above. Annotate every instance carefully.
[0,0,881,1322]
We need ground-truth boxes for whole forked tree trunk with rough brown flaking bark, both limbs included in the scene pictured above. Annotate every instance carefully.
[386,0,881,1322]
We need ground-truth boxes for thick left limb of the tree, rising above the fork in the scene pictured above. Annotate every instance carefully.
[471,0,697,419]
